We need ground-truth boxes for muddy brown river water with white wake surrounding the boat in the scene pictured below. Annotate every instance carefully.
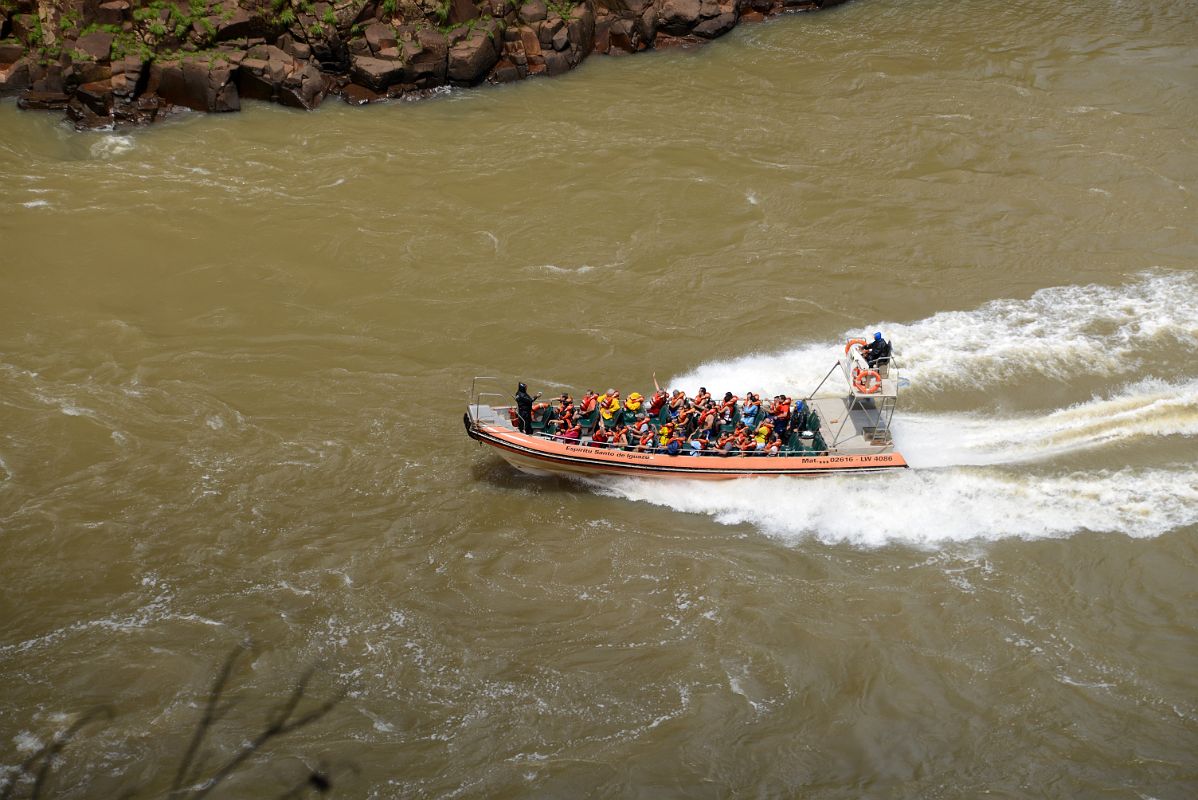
[0,0,1198,799]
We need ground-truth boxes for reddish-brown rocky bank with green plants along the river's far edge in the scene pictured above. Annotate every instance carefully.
[0,0,845,128]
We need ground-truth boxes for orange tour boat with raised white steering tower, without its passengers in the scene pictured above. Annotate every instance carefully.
[462,339,907,480]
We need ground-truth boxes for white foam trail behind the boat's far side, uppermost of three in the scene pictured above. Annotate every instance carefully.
[670,272,1198,395]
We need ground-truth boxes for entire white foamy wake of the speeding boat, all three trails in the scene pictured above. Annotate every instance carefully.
[592,273,1198,546]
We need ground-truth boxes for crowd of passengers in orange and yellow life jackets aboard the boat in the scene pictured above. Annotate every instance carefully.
[513,381,810,456]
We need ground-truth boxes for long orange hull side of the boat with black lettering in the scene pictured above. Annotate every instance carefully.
[464,414,907,480]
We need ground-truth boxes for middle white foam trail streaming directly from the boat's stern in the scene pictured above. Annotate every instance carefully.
[893,380,1198,467]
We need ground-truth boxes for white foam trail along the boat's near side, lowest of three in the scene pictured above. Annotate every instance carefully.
[592,468,1198,547]
